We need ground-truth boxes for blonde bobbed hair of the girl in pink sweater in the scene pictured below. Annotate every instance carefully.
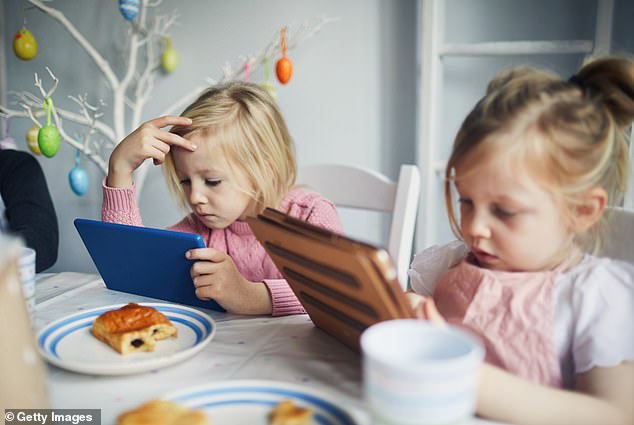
[163,81,297,211]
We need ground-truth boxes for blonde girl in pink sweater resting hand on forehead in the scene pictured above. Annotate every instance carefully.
[102,81,341,316]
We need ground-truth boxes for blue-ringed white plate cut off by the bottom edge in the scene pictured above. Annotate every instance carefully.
[163,380,357,425]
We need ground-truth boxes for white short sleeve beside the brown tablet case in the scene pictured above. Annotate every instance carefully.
[408,240,469,297]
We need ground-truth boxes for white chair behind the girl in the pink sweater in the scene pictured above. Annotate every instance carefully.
[298,164,420,289]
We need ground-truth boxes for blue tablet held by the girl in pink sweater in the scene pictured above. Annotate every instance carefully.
[75,218,225,311]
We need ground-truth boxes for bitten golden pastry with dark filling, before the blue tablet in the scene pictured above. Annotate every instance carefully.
[92,303,177,354]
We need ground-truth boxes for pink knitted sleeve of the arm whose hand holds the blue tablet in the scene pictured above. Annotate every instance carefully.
[264,194,343,316]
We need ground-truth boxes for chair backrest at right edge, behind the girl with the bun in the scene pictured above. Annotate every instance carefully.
[599,207,634,263]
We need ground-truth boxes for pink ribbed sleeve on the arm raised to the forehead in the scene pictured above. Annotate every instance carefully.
[101,179,143,226]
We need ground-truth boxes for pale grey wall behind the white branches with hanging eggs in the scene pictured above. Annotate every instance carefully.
[3,0,416,271]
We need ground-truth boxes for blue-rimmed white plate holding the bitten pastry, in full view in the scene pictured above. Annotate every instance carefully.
[37,303,216,375]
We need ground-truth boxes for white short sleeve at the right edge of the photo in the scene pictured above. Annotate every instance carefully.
[571,258,634,374]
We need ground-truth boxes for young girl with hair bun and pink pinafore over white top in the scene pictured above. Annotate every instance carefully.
[408,57,634,425]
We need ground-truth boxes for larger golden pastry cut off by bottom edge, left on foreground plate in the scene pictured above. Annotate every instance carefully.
[117,400,210,425]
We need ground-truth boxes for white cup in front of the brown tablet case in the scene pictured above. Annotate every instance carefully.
[361,319,484,425]
